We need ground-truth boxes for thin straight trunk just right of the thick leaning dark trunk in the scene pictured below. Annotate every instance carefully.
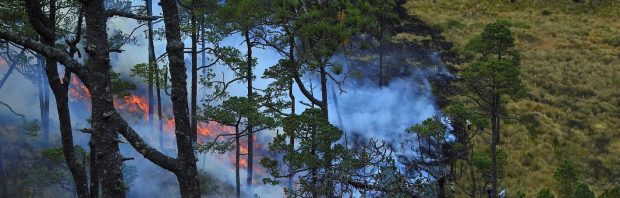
[190,1,198,142]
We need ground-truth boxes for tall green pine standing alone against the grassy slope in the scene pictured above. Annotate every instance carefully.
[461,22,524,195]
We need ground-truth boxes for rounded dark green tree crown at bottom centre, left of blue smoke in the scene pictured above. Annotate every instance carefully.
[260,109,345,194]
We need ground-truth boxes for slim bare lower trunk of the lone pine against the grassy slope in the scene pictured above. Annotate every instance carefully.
[491,94,500,197]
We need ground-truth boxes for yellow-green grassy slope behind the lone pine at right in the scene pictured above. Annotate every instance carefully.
[405,0,620,197]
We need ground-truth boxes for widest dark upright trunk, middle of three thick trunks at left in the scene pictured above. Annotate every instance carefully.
[83,1,126,197]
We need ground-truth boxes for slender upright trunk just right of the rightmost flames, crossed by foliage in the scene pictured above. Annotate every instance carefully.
[243,29,254,189]
